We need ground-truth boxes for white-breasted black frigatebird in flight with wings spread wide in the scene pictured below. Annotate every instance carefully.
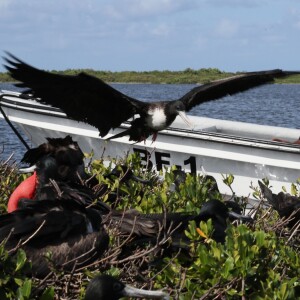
[4,53,300,142]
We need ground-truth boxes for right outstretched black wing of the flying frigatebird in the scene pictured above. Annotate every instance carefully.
[179,69,300,111]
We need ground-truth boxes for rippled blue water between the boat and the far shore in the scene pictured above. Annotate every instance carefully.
[0,83,300,161]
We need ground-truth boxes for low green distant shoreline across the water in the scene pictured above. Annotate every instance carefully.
[0,68,300,84]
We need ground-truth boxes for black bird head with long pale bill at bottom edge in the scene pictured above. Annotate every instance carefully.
[84,274,170,300]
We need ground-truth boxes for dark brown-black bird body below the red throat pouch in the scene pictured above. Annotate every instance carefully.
[0,199,109,277]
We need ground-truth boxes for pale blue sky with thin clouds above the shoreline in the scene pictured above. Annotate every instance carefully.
[0,0,300,72]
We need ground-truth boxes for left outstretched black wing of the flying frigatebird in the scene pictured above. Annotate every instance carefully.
[5,54,140,136]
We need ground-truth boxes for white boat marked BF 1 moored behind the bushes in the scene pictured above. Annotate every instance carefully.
[0,91,300,196]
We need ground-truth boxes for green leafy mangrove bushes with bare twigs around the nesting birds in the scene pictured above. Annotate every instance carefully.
[0,155,300,300]
